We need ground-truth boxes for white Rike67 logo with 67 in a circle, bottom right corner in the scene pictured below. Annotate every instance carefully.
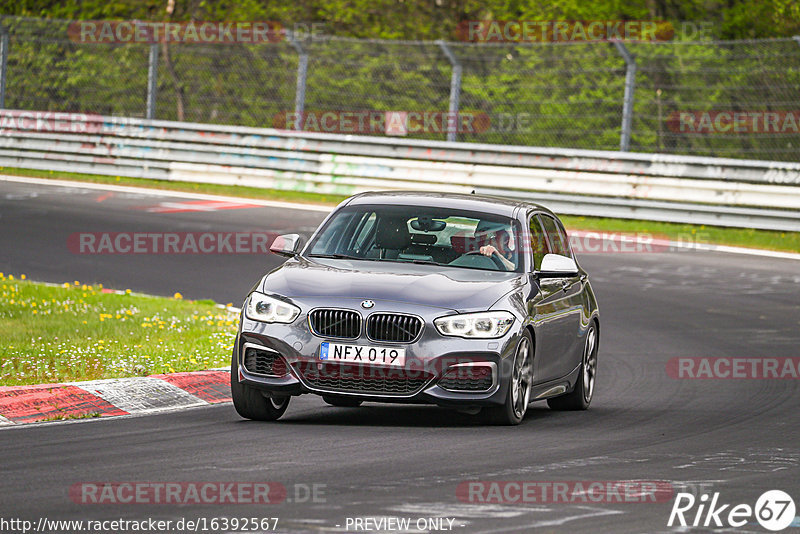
[667,490,796,532]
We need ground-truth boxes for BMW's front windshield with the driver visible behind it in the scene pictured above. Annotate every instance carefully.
[308,205,522,272]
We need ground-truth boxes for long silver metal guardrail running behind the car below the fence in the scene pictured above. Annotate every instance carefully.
[0,110,800,231]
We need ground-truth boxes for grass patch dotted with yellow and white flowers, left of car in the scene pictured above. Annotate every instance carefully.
[0,273,237,386]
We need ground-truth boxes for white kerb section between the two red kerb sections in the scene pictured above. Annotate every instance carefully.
[69,377,208,413]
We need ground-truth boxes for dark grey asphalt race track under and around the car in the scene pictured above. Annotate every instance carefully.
[0,177,800,533]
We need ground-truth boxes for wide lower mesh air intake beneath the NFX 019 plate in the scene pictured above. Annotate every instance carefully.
[294,362,433,395]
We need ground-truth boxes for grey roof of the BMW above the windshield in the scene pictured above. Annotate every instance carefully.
[346,191,552,217]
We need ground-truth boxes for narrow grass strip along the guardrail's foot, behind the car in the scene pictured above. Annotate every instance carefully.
[0,167,800,252]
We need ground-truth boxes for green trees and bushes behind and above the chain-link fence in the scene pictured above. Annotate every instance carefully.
[0,0,800,160]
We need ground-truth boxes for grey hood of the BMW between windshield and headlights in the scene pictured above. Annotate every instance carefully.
[260,257,524,312]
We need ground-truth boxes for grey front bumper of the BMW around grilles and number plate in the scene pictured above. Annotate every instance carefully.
[234,299,520,407]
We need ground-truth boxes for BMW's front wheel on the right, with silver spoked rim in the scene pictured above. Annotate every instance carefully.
[488,329,533,425]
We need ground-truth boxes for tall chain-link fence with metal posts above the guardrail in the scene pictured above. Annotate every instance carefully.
[0,17,800,161]
